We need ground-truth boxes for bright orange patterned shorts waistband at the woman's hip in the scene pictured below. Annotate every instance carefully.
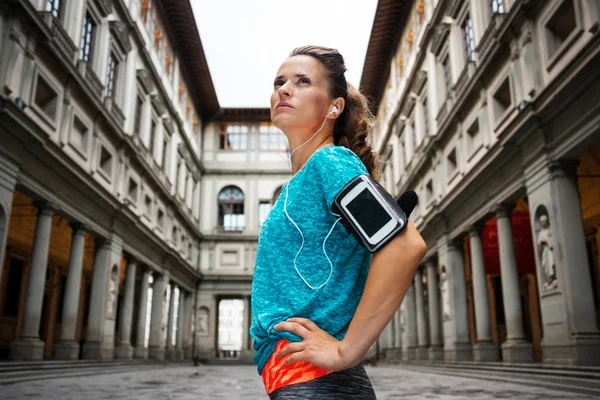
[262,339,333,395]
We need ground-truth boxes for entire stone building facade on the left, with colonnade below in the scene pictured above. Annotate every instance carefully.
[0,0,219,360]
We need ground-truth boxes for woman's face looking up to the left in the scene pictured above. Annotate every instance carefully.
[271,55,333,133]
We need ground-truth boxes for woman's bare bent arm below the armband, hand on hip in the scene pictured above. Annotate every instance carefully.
[275,221,426,371]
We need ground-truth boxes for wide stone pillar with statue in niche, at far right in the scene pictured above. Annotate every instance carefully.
[526,161,600,365]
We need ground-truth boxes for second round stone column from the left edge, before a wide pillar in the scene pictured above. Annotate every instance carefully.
[54,224,85,360]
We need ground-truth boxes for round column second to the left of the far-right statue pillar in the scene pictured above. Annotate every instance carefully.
[469,226,500,361]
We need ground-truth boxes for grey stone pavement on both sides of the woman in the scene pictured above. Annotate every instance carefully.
[0,366,592,400]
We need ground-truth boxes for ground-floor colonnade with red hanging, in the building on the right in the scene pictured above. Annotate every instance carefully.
[379,145,600,364]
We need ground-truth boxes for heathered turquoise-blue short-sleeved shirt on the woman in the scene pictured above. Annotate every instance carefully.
[250,146,371,374]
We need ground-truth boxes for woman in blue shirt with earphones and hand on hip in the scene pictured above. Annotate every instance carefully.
[250,46,425,400]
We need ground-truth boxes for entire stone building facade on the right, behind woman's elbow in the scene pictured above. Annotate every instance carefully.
[368,0,600,365]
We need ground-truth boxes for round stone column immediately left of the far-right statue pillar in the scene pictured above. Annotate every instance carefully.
[496,206,533,363]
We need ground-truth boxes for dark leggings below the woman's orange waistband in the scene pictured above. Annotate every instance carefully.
[269,364,377,400]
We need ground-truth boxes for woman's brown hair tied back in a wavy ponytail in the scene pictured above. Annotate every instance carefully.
[290,46,380,180]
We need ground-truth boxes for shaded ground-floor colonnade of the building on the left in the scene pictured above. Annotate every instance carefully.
[0,190,192,360]
